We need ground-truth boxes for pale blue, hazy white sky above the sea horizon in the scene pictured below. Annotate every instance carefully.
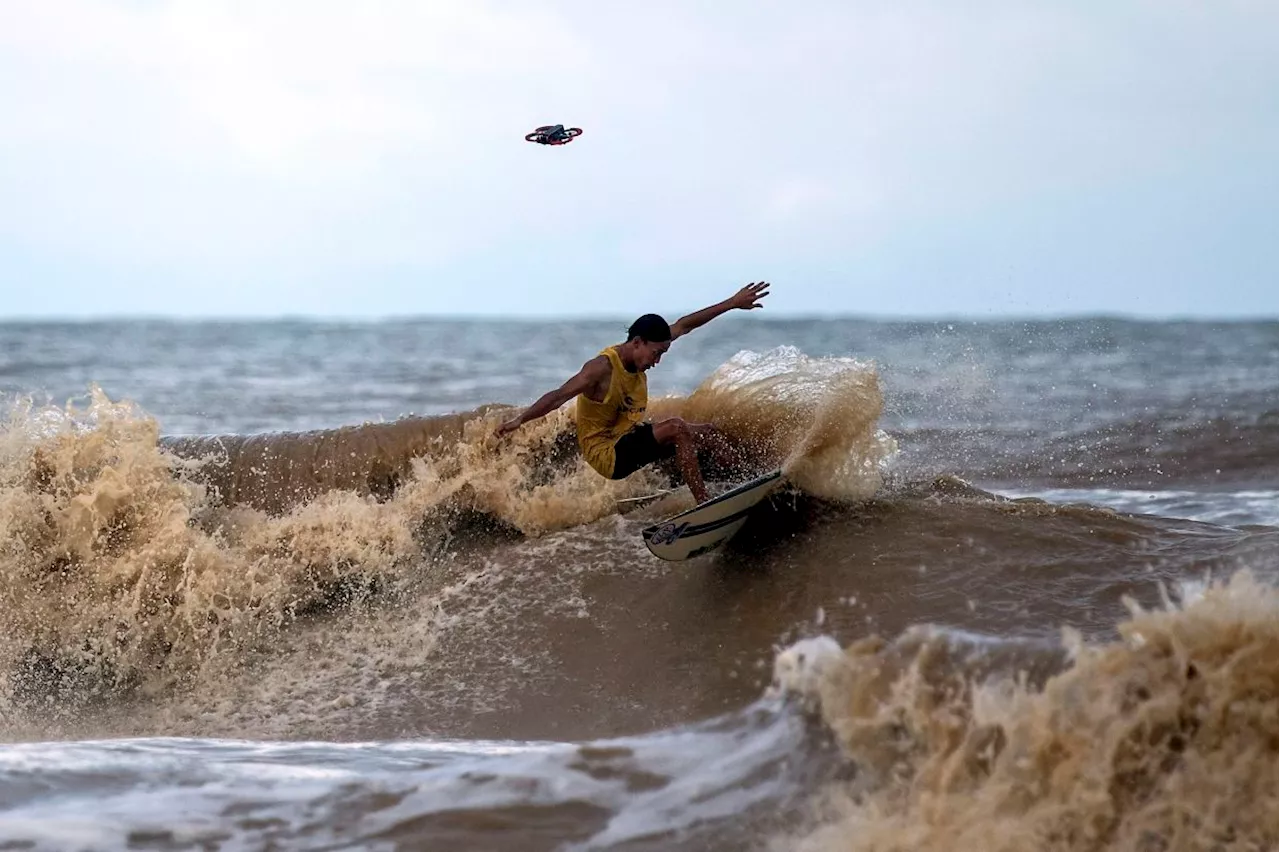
[0,0,1280,319]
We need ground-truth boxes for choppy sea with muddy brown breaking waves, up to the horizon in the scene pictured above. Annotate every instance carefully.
[0,315,1280,852]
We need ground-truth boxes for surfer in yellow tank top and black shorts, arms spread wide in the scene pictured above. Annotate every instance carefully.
[497,281,769,503]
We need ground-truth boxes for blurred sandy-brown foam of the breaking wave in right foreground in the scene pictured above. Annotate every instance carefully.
[778,571,1280,852]
